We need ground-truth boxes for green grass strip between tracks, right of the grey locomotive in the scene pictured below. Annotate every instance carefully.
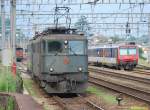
[87,86,117,104]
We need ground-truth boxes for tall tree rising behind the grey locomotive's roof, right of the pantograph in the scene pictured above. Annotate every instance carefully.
[75,16,91,34]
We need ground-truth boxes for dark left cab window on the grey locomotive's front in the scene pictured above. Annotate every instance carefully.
[47,41,62,53]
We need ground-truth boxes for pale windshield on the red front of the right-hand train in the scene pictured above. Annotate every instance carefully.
[120,48,136,55]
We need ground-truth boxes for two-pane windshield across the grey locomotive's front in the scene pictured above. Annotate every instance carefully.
[43,40,86,55]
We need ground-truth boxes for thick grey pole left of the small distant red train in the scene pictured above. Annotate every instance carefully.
[10,0,16,63]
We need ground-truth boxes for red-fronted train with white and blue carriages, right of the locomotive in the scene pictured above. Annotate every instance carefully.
[88,45,139,70]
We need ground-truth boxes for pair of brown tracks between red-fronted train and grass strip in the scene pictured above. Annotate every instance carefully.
[89,67,150,103]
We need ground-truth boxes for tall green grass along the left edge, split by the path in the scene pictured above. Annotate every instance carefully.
[0,66,20,110]
